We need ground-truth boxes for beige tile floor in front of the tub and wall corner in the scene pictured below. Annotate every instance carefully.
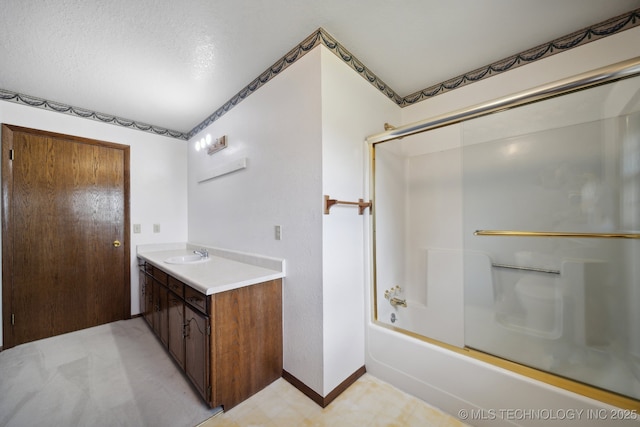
[199,374,465,427]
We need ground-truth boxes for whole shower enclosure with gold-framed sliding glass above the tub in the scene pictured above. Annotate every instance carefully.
[372,59,640,407]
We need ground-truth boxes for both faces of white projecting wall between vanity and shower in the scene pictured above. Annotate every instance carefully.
[188,46,399,396]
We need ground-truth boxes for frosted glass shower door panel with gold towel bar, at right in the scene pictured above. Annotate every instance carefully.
[462,77,640,399]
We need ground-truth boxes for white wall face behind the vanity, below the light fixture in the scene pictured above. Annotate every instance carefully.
[187,49,323,393]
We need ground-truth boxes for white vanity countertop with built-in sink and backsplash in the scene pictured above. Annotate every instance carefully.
[137,243,285,295]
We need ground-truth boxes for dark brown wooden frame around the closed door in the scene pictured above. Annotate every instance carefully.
[0,123,131,351]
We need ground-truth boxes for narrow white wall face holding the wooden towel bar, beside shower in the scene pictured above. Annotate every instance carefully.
[322,48,400,395]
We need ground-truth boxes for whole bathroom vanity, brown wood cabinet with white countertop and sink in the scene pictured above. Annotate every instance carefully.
[137,244,284,410]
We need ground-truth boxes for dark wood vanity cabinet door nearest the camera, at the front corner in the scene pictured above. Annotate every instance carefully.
[184,305,211,402]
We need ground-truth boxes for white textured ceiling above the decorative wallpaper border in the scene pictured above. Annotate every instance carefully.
[0,0,640,132]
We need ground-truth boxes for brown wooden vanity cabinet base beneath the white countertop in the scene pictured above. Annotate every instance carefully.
[140,263,282,410]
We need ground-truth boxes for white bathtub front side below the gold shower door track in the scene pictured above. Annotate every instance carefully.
[366,320,640,427]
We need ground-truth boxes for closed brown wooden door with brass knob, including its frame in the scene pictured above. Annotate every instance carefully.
[2,125,131,347]
